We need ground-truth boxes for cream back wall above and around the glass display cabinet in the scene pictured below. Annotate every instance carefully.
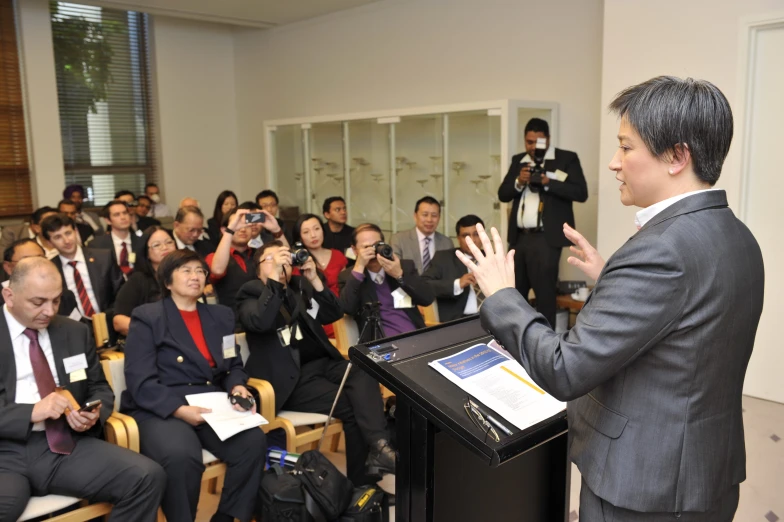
[235,0,603,278]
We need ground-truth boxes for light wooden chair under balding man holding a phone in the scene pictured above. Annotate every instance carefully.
[19,360,132,522]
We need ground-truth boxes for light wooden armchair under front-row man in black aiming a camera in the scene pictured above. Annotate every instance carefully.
[235,332,343,453]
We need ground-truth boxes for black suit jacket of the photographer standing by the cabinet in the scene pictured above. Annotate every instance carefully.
[498,149,588,244]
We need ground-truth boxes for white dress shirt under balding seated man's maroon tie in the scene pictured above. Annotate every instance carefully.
[3,305,60,431]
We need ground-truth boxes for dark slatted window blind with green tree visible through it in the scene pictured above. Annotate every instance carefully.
[51,2,157,206]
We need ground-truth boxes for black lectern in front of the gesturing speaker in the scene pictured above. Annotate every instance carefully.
[349,317,570,522]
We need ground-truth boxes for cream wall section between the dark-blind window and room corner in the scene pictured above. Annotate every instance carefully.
[152,16,240,214]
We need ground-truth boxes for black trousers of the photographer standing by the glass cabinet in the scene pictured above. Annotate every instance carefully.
[511,231,561,328]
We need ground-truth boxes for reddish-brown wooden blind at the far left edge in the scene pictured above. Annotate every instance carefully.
[0,0,33,216]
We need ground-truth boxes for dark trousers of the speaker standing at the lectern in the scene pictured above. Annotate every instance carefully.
[580,480,740,522]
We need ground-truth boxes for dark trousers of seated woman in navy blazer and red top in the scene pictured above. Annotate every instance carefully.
[139,417,267,522]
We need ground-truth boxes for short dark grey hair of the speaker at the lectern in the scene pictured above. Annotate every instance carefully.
[610,76,733,185]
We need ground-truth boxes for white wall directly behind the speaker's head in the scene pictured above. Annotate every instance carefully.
[598,0,781,258]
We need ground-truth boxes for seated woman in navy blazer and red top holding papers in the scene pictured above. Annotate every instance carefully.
[122,250,267,522]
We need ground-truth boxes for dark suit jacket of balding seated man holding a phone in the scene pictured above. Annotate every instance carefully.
[0,313,114,442]
